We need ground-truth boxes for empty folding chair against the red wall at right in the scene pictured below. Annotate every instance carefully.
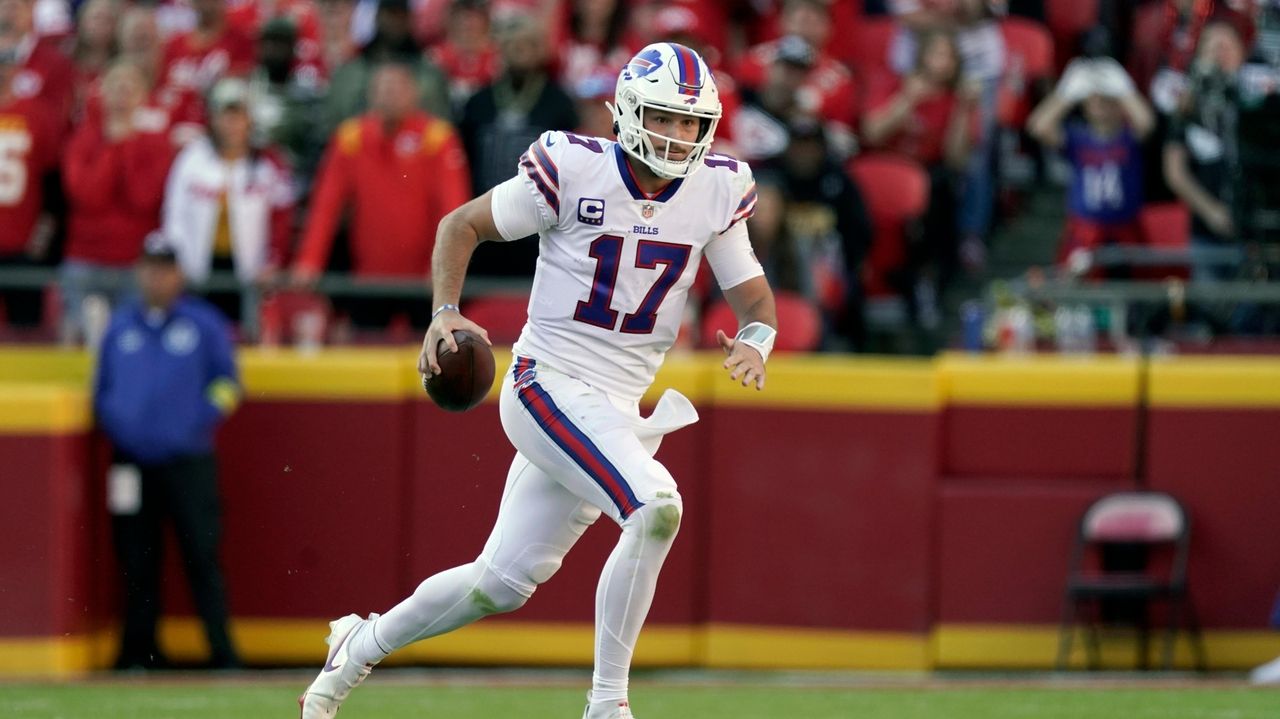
[1057,491,1206,670]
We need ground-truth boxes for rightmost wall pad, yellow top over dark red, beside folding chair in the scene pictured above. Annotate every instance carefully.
[1147,358,1280,629]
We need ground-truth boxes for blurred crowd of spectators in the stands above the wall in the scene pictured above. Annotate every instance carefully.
[0,0,1280,352]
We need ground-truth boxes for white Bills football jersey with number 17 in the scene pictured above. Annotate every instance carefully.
[493,132,764,400]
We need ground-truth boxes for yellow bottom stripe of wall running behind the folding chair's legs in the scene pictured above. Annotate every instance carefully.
[933,624,1280,669]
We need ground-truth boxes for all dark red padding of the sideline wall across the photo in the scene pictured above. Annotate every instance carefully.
[17,386,1280,649]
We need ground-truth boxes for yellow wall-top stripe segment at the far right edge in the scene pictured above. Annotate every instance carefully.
[1149,357,1280,408]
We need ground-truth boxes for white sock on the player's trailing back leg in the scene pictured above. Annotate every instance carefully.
[351,562,529,664]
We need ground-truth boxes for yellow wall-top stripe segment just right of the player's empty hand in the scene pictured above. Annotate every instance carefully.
[704,354,942,412]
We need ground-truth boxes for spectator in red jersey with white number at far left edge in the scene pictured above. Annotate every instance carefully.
[0,55,58,325]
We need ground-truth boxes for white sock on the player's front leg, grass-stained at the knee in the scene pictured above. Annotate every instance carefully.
[591,502,680,704]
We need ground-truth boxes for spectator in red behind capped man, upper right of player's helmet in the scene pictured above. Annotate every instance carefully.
[733,0,858,130]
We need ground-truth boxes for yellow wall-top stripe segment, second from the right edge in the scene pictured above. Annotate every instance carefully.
[937,354,1140,407]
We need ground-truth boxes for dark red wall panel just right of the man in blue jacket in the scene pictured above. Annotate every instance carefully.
[219,402,409,617]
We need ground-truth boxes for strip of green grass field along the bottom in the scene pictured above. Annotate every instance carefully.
[0,670,1280,719]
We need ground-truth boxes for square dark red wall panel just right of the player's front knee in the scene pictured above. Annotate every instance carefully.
[708,408,937,632]
